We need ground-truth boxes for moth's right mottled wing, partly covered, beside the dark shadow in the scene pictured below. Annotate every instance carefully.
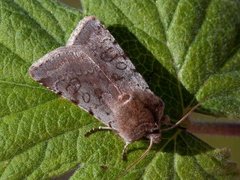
[67,16,149,92]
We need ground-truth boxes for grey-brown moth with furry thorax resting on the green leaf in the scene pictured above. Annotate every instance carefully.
[29,16,197,163]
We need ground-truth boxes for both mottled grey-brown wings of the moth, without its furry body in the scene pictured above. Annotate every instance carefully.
[29,16,152,129]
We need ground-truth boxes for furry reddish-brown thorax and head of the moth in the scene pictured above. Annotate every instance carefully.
[114,92,160,143]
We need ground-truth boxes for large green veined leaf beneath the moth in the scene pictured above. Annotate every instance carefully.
[0,0,240,179]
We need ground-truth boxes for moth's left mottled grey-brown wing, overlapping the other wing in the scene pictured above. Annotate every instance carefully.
[29,46,119,126]
